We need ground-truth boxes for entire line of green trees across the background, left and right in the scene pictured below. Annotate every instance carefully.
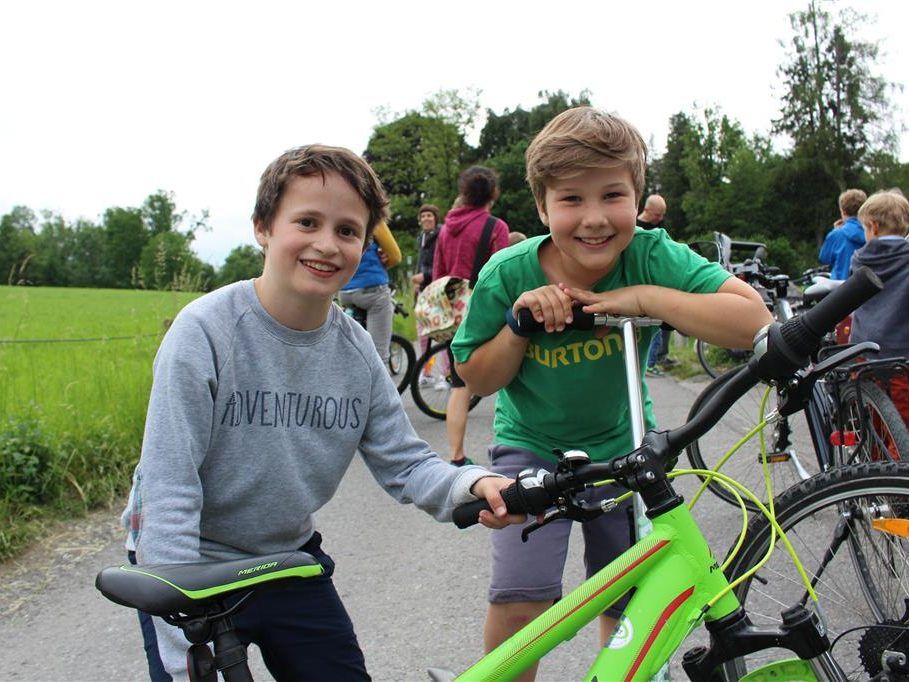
[0,0,909,291]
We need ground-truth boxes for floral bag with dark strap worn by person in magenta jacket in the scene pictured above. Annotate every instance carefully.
[414,216,496,343]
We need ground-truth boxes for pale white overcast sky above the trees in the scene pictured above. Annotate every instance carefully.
[0,0,909,265]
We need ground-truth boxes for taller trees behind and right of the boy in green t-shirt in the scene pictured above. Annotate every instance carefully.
[365,0,909,273]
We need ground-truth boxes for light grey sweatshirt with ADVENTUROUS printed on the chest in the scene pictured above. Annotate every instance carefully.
[123,280,489,679]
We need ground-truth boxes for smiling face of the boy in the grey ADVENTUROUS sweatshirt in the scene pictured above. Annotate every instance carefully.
[255,173,369,329]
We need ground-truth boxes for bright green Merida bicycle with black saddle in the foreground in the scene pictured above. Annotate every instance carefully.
[96,271,909,682]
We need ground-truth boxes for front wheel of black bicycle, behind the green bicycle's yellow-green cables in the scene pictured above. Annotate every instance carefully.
[686,370,821,512]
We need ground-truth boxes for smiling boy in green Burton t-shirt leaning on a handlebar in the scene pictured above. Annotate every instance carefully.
[452,107,772,679]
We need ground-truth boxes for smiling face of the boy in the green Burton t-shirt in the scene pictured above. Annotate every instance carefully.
[537,165,637,288]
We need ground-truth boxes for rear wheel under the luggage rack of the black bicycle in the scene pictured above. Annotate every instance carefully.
[842,381,909,464]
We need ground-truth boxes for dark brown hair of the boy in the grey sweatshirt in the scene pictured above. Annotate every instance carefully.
[252,144,388,236]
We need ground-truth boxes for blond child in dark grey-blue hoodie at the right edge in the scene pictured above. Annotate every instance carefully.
[849,183,909,425]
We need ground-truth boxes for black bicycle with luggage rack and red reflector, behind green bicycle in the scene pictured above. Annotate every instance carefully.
[687,268,909,511]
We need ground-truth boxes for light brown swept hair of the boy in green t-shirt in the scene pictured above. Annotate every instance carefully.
[524,107,647,205]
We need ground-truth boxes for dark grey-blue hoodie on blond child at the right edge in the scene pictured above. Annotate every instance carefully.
[849,236,909,358]
